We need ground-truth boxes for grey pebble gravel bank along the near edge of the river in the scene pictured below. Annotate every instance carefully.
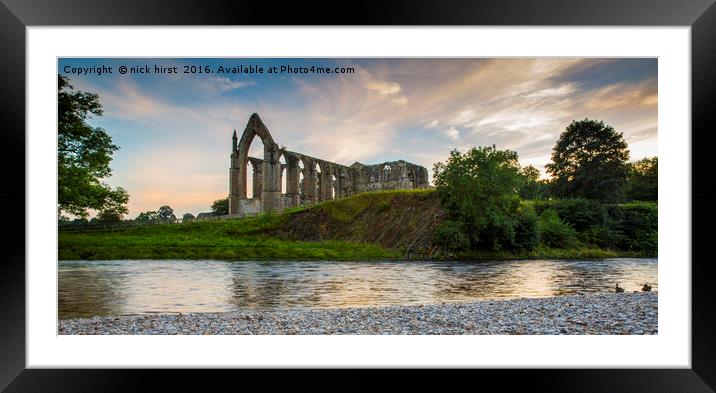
[59,292,658,334]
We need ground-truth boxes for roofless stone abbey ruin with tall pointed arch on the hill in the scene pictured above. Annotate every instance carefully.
[229,113,429,215]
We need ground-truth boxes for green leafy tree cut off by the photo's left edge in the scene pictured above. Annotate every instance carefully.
[57,75,129,217]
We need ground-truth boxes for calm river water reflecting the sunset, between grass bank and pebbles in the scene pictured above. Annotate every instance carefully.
[58,258,657,319]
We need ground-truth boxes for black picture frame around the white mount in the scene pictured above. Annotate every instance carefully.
[0,0,716,392]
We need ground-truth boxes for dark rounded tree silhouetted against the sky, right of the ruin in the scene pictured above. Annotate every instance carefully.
[547,119,629,202]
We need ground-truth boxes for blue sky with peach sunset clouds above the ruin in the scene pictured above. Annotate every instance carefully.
[58,58,657,218]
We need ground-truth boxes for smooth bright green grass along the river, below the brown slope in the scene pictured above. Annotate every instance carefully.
[59,209,398,260]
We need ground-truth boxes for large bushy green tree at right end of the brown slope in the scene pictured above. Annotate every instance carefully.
[433,145,523,250]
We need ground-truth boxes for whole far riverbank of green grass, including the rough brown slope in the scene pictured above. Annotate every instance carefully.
[59,190,656,260]
